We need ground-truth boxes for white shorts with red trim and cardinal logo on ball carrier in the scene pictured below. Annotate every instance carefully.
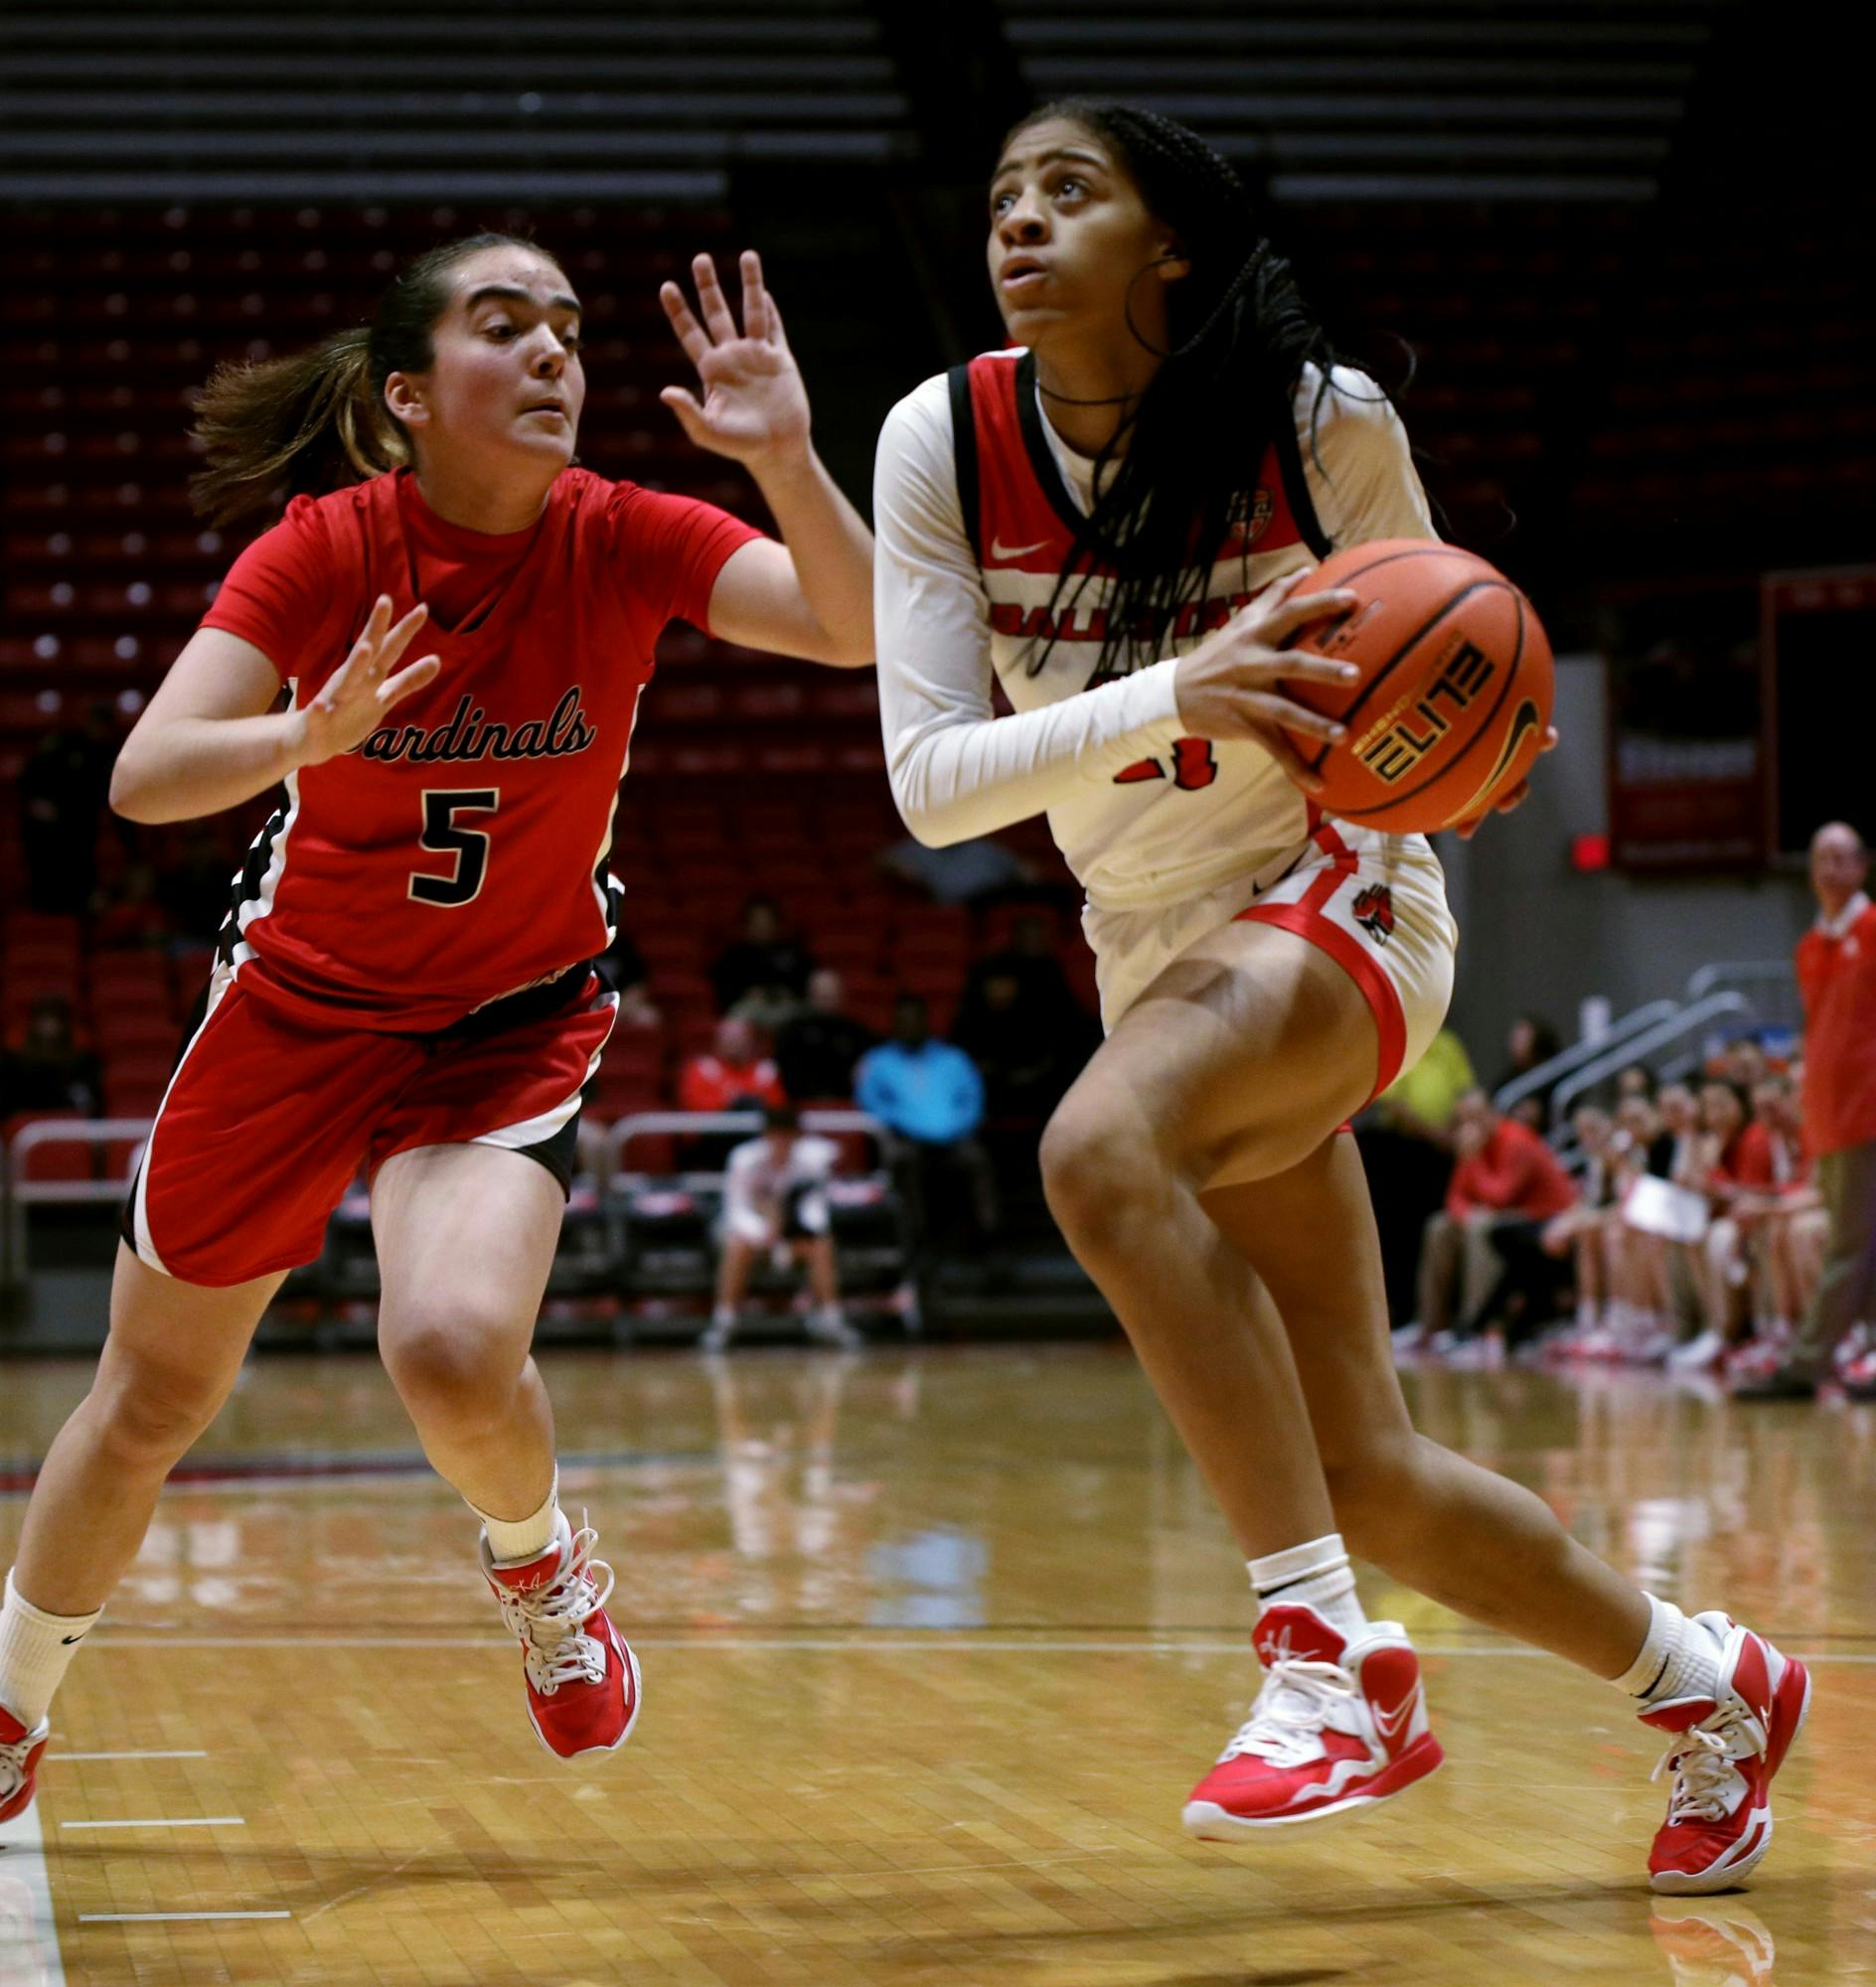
[1081,821,1459,1097]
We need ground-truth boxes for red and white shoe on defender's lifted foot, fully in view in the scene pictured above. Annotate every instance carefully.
[481,1516,638,1758]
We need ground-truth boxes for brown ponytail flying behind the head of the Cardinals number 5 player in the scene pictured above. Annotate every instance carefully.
[189,330,409,525]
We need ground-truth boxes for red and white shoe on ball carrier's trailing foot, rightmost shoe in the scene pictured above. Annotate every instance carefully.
[1642,1611,1810,1896]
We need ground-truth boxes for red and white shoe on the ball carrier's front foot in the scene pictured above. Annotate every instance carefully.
[1184,1602,1445,1842]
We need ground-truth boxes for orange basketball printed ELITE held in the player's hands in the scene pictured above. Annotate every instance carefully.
[1284,538,1554,835]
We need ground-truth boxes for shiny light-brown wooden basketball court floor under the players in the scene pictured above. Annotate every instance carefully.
[0,1345,1876,1987]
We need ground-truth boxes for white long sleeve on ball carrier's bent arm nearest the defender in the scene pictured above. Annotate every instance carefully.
[872,378,1180,848]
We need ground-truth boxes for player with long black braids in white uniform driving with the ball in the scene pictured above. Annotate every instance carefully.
[874,103,1808,1892]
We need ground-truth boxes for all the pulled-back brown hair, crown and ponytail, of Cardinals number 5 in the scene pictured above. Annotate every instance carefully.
[189,234,535,525]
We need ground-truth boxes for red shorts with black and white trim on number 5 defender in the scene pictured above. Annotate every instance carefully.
[123,966,618,1288]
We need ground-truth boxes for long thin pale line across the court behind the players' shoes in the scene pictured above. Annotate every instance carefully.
[74,1631,1876,1663]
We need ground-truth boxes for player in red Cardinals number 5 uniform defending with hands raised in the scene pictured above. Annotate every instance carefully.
[0,234,872,1820]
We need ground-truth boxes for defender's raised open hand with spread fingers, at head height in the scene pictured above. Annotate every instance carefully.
[658,248,809,467]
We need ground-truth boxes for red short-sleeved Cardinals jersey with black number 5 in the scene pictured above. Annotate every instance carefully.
[203,469,757,1031]
